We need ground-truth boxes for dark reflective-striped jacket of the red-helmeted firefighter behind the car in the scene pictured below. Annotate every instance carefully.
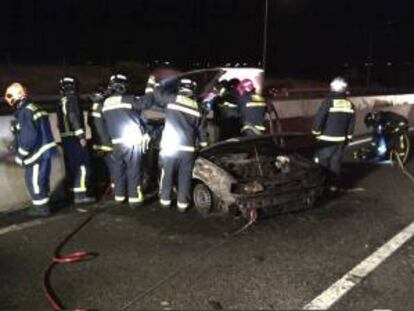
[240,93,266,134]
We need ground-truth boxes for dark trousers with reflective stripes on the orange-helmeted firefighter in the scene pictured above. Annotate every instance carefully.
[25,158,52,206]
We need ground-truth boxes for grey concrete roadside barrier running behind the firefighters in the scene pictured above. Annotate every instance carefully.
[0,95,414,213]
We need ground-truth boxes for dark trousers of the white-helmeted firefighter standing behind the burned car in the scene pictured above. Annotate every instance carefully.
[315,143,346,180]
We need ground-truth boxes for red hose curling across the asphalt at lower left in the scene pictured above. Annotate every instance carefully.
[43,183,111,311]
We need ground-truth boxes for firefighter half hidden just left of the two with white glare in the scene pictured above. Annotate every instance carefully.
[88,87,113,190]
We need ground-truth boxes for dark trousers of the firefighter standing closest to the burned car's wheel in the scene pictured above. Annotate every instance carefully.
[160,151,194,208]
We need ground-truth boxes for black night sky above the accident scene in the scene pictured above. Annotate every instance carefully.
[0,0,414,82]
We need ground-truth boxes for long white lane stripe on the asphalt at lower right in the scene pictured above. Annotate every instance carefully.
[303,222,414,310]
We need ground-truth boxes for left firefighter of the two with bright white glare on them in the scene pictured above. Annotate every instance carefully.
[102,74,150,208]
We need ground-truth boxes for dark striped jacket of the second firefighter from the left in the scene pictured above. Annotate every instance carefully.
[57,94,85,138]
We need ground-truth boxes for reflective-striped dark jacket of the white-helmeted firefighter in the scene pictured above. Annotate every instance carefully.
[312,93,355,143]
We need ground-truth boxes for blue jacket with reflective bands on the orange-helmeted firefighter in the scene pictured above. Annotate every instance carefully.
[15,101,57,166]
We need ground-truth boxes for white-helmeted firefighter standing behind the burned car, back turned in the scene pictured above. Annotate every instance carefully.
[312,77,355,191]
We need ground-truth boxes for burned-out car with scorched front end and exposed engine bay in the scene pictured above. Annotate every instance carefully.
[193,135,325,217]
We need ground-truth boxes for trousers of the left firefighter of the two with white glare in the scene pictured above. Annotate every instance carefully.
[111,144,143,203]
